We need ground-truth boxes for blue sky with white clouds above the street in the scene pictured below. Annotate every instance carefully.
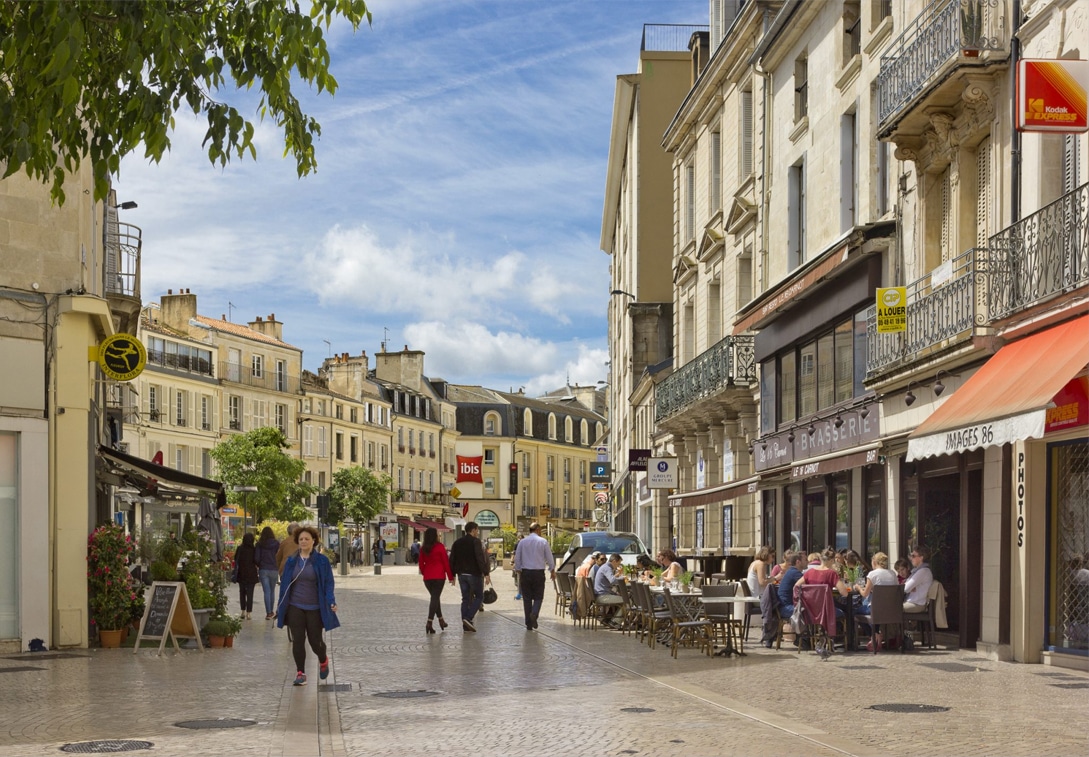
[114,0,708,395]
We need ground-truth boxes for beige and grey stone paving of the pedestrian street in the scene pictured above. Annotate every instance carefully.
[0,566,1089,757]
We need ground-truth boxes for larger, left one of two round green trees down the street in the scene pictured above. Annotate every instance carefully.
[208,426,317,524]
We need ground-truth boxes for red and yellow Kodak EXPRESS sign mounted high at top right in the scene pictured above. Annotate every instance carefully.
[1017,60,1089,134]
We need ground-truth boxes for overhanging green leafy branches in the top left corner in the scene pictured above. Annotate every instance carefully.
[0,0,371,204]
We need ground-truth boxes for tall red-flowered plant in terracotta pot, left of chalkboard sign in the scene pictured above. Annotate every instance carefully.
[87,523,135,647]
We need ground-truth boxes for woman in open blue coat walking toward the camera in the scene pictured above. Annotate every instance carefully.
[276,526,340,686]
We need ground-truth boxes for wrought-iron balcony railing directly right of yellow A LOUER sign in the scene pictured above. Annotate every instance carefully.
[866,247,989,379]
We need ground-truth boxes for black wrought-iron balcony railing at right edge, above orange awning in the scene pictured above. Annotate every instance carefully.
[988,184,1089,320]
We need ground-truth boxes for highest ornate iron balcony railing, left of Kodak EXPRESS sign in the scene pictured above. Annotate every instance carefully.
[878,0,1010,126]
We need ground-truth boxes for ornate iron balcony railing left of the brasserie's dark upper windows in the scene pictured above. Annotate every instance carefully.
[654,337,756,422]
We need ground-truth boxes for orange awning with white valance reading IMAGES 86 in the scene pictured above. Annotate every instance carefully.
[907,316,1089,461]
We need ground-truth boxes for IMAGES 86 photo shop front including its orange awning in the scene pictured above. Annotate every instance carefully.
[901,316,1089,667]
